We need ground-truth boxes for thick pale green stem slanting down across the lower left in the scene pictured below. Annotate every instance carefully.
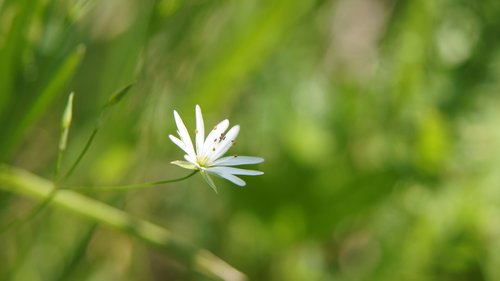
[0,165,246,281]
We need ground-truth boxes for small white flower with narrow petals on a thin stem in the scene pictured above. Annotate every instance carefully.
[169,105,264,192]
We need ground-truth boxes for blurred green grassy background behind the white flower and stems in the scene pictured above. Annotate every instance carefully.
[0,0,500,281]
